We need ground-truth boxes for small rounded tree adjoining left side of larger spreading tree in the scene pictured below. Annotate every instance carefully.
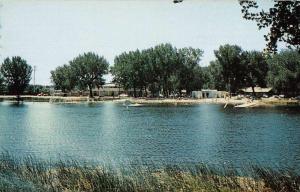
[51,65,77,92]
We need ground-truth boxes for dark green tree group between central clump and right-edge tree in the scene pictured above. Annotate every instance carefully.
[203,45,268,93]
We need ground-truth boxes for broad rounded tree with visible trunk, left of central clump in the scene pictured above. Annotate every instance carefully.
[70,52,109,97]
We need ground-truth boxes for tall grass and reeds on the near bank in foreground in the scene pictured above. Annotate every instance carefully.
[0,153,300,192]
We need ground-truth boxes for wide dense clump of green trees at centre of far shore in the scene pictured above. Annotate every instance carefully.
[111,44,203,96]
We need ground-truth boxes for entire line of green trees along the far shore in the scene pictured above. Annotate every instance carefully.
[0,44,300,97]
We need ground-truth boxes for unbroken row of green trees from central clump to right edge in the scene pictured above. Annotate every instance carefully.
[111,44,300,97]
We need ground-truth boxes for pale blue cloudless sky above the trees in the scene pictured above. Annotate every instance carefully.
[0,0,272,84]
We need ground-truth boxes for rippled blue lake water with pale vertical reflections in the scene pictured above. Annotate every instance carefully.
[0,102,300,170]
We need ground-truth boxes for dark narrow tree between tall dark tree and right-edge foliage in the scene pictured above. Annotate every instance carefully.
[242,51,268,95]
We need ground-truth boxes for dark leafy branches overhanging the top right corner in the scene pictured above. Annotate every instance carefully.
[240,1,300,52]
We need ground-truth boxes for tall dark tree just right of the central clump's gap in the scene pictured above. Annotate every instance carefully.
[215,44,245,93]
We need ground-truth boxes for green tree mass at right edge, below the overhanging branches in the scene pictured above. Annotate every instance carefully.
[267,50,300,96]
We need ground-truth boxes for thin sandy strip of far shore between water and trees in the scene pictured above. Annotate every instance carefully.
[0,95,300,107]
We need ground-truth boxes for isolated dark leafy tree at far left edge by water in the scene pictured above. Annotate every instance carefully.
[0,56,32,96]
